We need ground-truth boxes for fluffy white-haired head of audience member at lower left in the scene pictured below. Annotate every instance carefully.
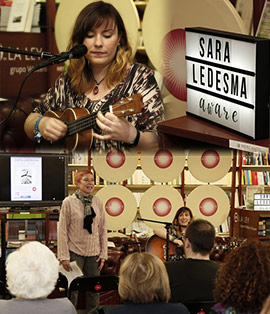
[6,241,59,299]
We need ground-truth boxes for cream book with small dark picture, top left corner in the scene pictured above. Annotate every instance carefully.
[7,0,36,32]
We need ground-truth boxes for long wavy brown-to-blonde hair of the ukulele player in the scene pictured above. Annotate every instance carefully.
[67,1,133,95]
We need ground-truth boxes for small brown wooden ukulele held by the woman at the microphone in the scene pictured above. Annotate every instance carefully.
[44,94,143,151]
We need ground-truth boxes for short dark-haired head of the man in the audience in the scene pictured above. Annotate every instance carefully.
[185,219,215,256]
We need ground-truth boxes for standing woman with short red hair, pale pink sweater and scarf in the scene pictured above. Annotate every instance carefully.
[57,170,107,309]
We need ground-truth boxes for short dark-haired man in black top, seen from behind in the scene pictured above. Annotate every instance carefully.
[165,219,219,303]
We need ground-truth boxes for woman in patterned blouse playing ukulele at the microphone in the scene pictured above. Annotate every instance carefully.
[25,1,164,151]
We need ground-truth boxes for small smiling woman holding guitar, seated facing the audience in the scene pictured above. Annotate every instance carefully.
[154,206,193,259]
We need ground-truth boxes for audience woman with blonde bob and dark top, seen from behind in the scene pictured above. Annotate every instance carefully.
[106,252,189,314]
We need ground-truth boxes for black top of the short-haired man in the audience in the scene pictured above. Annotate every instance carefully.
[165,258,220,303]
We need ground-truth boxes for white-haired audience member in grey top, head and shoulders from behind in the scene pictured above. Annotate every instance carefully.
[0,241,76,314]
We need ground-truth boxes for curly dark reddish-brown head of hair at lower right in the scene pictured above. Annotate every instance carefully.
[213,240,270,313]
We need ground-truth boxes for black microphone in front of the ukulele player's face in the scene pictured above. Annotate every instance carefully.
[34,45,87,71]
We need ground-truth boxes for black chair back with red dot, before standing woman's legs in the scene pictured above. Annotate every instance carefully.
[68,275,119,299]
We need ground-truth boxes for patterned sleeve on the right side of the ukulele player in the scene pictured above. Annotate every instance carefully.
[127,65,164,131]
